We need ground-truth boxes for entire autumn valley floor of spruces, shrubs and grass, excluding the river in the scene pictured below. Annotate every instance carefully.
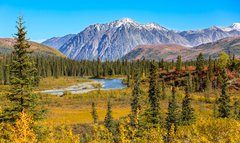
[0,18,240,143]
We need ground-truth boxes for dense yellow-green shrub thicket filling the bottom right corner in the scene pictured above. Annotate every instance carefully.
[176,118,240,143]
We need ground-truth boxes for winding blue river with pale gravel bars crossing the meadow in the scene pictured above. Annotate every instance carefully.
[41,79,126,96]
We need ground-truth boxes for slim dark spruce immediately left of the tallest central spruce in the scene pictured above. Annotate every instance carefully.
[131,75,141,128]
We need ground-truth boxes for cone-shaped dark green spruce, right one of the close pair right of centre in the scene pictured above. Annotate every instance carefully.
[181,86,195,125]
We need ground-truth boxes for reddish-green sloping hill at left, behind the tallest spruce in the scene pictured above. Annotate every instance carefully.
[0,38,66,57]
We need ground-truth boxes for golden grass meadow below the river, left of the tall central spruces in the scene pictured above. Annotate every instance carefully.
[41,85,131,126]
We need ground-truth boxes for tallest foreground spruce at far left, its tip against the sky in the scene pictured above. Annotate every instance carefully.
[1,17,41,121]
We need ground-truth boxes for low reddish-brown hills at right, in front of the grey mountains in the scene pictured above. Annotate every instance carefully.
[123,37,240,61]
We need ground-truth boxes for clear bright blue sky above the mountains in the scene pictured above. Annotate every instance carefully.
[0,0,240,41]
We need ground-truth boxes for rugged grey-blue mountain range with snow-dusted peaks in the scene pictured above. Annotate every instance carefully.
[43,18,240,60]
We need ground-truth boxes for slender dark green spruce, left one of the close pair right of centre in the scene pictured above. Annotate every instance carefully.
[166,86,178,134]
